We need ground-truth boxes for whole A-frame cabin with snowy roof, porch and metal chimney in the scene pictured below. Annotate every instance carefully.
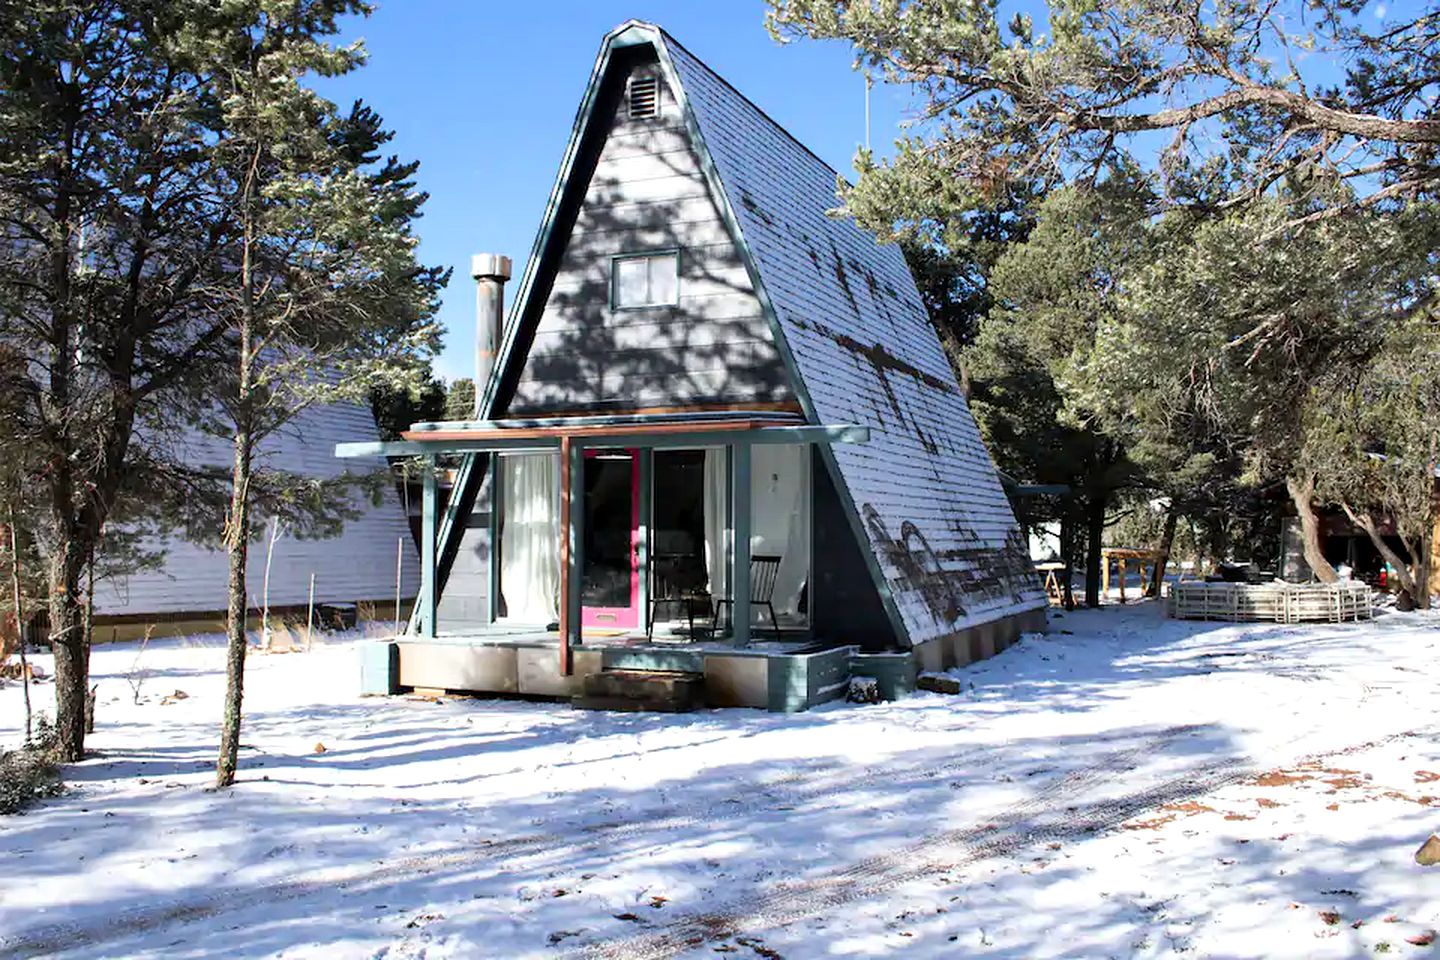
[338,22,1045,710]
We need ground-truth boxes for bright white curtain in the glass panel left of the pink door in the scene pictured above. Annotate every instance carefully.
[500,453,560,623]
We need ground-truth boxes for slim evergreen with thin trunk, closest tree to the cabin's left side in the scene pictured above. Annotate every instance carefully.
[189,0,448,786]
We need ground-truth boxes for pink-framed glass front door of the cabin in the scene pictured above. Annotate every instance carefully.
[580,450,639,629]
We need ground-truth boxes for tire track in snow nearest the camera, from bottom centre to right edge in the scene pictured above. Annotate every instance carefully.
[564,728,1434,960]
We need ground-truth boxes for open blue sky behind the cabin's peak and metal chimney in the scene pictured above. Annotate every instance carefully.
[320,0,910,379]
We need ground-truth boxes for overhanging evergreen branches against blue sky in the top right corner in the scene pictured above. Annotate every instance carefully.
[768,0,1440,213]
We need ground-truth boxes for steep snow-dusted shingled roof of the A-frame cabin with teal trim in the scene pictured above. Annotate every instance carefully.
[485,22,1044,645]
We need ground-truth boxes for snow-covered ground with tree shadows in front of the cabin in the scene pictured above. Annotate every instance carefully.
[0,603,1440,960]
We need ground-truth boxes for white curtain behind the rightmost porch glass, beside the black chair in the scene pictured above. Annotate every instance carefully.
[750,443,811,617]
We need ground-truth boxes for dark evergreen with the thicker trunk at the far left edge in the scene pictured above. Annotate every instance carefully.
[0,0,236,760]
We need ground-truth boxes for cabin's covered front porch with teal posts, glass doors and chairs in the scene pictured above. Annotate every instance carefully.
[337,412,892,710]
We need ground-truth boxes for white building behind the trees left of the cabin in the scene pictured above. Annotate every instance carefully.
[95,404,420,642]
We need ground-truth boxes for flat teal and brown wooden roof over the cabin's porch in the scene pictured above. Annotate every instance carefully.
[336,415,870,456]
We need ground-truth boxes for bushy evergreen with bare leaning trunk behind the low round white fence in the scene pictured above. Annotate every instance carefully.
[1084,193,1436,580]
